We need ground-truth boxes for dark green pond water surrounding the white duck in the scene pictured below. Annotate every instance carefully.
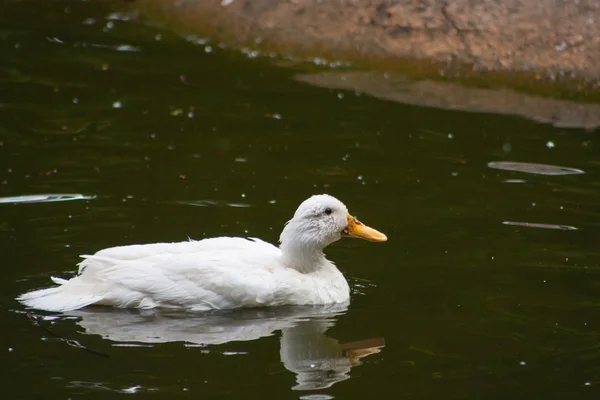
[0,1,600,399]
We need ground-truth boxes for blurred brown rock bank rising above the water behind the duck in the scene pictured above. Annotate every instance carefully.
[130,0,600,86]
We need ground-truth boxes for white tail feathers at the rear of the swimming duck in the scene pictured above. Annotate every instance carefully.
[17,277,102,312]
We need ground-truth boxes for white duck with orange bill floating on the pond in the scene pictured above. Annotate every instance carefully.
[17,194,387,311]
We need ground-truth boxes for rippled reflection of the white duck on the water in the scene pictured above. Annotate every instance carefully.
[69,304,384,390]
